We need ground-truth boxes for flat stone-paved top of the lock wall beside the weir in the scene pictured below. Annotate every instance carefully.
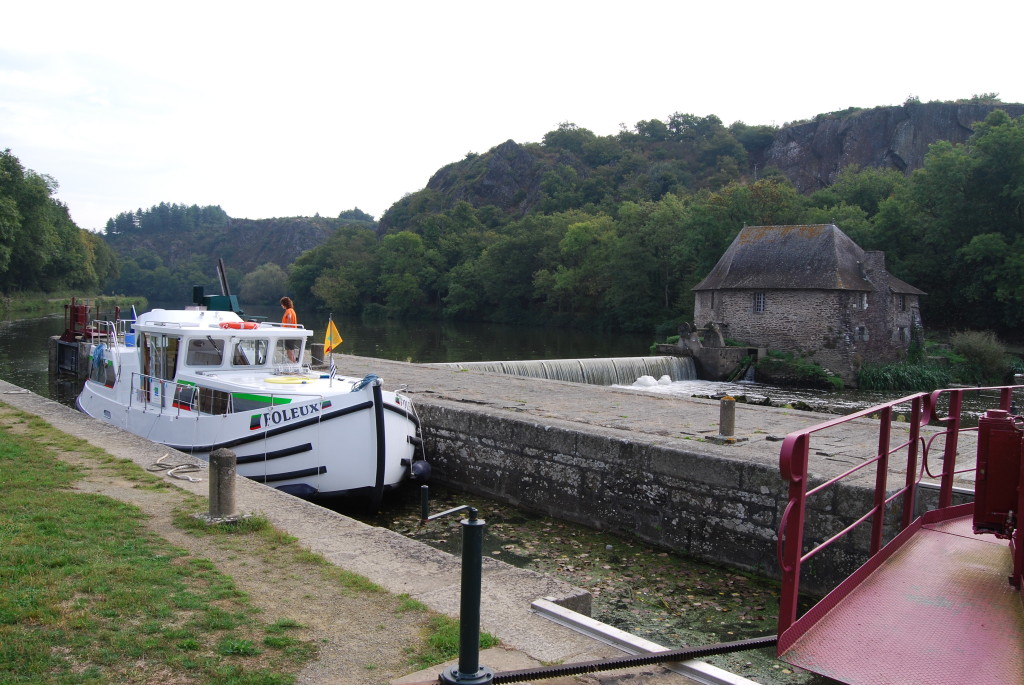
[335,354,975,487]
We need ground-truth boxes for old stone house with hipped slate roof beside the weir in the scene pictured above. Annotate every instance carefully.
[693,224,925,383]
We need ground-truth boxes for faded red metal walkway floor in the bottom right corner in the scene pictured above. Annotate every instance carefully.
[781,516,1024,685]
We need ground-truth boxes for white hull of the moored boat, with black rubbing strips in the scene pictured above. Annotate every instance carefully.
[78,380,419,497]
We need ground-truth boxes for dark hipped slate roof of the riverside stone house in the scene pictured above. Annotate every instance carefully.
[693,223,924,295]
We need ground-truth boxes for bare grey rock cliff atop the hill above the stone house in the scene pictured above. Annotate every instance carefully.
[762,101,1024,192]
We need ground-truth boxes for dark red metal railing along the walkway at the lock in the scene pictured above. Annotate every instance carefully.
[778,386,1024,653]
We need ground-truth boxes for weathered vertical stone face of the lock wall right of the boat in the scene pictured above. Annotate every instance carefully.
[419,402,872,591]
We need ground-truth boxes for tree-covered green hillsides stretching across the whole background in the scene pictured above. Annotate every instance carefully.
[0,100,1024,340]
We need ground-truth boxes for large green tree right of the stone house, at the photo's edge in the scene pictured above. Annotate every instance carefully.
[873,111,1024,334]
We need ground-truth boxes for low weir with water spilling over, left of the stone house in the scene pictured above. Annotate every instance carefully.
[422,356,697,385]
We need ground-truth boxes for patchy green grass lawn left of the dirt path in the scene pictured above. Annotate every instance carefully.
[0,409,315,685]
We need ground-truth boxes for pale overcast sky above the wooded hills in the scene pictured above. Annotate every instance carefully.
[0,0,1024,230]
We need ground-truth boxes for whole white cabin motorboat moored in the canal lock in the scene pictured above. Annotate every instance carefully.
[77,307,429,507]
